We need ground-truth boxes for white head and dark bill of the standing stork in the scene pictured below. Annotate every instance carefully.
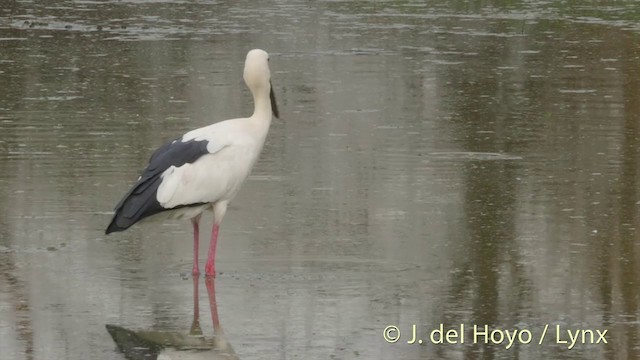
[244,49,279,117]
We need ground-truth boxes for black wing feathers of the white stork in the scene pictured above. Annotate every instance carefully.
[105,139,209,234]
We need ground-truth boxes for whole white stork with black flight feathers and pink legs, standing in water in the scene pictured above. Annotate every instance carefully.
[106,49,278,276]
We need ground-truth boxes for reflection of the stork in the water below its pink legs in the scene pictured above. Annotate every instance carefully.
[106,277,239,360]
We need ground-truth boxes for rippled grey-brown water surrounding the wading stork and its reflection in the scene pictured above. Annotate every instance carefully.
[0,0,640,359]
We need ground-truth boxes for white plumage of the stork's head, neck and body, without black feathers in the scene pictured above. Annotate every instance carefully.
[152,49,277,224]
